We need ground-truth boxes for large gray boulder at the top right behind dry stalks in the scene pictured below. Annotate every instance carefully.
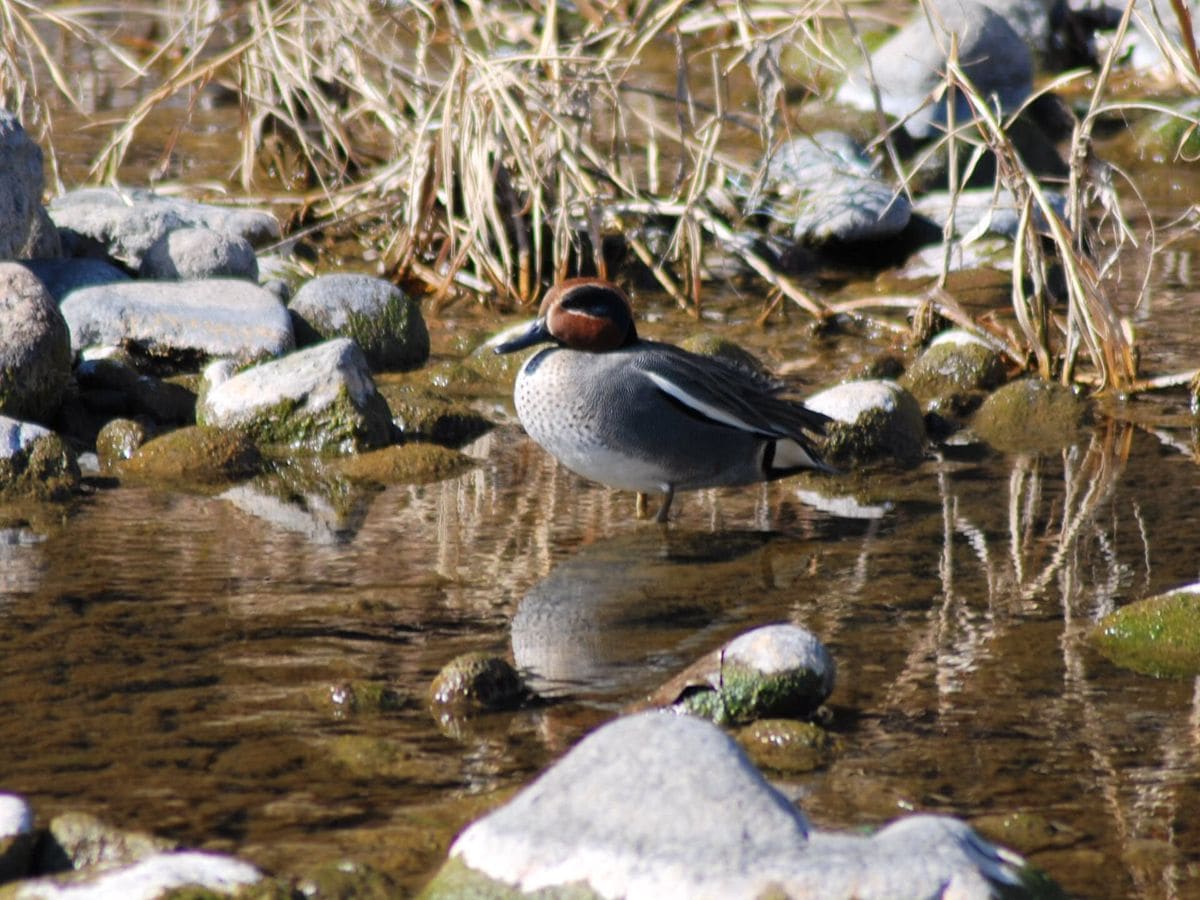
[836,0,1033,139]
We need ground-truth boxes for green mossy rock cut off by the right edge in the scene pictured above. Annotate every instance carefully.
[1091,584,1200,678]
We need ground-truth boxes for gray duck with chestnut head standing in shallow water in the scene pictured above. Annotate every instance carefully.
[494,277,834,523]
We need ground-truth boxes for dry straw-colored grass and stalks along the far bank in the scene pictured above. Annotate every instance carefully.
[0,0,1200,391]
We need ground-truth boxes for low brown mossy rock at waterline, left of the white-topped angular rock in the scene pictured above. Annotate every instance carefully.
[119,425,263,486]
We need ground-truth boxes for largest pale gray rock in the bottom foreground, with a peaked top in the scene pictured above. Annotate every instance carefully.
[434,713,1049,900]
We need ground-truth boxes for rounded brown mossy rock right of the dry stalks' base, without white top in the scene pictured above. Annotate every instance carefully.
[971,378,1088,452]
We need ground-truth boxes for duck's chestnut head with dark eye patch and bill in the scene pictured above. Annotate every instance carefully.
[496,278,637,353]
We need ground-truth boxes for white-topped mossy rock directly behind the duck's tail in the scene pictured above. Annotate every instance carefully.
[804,379,925,466]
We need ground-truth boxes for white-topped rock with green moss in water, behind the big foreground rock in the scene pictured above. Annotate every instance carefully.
[652,625,836,725]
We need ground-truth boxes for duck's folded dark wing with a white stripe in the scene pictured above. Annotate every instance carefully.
[637,341,829,444]
